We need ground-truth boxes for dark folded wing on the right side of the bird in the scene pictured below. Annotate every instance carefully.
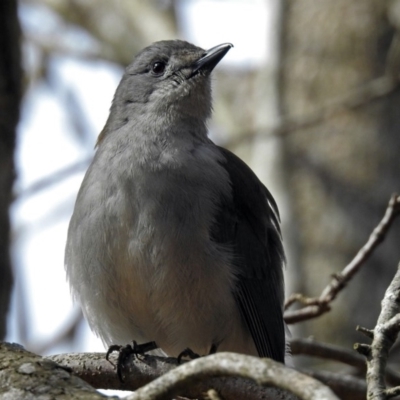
[211,147,285,362]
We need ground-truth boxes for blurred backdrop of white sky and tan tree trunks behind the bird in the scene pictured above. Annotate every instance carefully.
[0,0,400,376]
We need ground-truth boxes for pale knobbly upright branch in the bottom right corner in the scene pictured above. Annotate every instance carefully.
[356,264,400,400]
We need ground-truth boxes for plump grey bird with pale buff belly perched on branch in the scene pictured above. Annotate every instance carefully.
[65,40,285,362]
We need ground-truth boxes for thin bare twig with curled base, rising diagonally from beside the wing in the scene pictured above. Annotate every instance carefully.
[285,194,400,324]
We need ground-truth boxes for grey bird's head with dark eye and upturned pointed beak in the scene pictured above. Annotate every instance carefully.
[99,40,232,141]
